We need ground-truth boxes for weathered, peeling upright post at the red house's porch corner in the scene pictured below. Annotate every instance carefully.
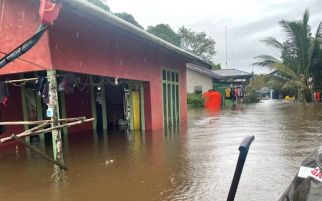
[47,70,64,162]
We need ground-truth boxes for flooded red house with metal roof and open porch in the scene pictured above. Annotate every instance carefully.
[0,0,209,140]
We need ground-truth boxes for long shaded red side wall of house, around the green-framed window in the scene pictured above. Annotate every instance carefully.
[49,9,187,130]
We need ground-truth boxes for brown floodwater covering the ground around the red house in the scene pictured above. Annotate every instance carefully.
[0,101,322,201]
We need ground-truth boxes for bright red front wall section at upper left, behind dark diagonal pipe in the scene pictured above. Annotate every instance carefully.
[0,0,52,75]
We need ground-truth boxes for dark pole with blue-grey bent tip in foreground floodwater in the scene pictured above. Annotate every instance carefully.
[227,136,254,201]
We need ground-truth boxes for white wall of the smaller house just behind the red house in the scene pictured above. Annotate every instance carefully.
[187,68,213,93]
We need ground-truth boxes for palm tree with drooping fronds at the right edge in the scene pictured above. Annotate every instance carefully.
[253,10,322,102]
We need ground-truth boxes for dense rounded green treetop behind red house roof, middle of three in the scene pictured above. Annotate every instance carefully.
[147,24,180,47]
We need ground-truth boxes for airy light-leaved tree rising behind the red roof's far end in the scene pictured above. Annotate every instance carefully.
[178,26,216,63]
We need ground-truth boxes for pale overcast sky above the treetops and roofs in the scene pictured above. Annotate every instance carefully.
[105,0,322,73]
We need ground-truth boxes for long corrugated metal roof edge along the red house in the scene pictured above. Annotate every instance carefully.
[62,0,211,68]
